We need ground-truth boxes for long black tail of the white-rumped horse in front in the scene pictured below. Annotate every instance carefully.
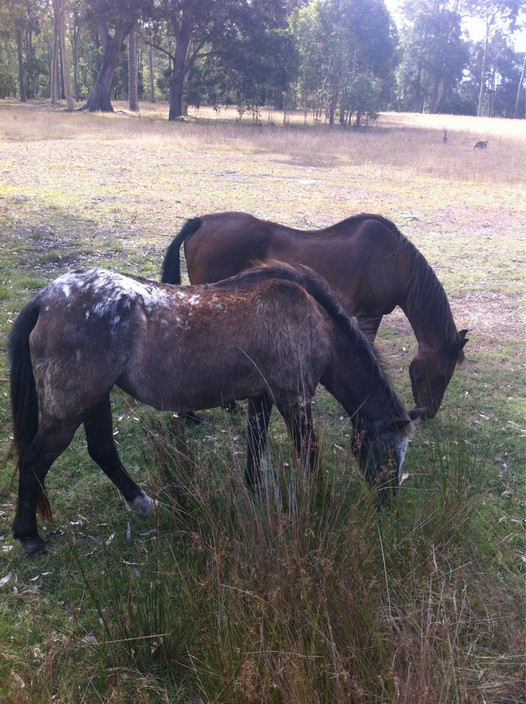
[7,299,52,521]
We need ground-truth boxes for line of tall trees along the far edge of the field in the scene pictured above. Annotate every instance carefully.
[0,0,526,121]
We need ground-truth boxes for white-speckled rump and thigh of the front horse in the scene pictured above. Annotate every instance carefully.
[29,269,146,418]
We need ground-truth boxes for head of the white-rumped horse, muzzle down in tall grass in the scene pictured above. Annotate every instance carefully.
[352,409,421,505]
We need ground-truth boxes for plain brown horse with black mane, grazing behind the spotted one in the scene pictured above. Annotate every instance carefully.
[162,212,467,418]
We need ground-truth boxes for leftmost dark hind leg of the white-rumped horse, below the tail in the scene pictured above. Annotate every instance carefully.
[13,420,79,555]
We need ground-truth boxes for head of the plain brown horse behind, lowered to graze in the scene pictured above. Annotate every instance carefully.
[409,330,467,418]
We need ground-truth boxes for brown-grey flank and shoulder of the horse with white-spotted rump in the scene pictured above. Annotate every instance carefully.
[117,278,331,412]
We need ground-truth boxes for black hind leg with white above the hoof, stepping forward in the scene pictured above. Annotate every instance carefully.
[84,396,155,516]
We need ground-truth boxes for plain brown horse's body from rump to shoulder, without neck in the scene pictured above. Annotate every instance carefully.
[185,212,409,315]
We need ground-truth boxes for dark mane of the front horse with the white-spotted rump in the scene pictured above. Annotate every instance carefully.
[210,260,407,417]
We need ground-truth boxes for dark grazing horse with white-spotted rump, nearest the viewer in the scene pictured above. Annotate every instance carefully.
[8,264,418,554]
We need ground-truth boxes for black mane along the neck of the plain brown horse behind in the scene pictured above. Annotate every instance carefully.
[344,214,463,362]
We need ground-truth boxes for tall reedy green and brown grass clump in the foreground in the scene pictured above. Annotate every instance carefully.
[65,410,522,704]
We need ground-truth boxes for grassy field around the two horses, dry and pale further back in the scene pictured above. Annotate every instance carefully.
[0,101,526,704]
